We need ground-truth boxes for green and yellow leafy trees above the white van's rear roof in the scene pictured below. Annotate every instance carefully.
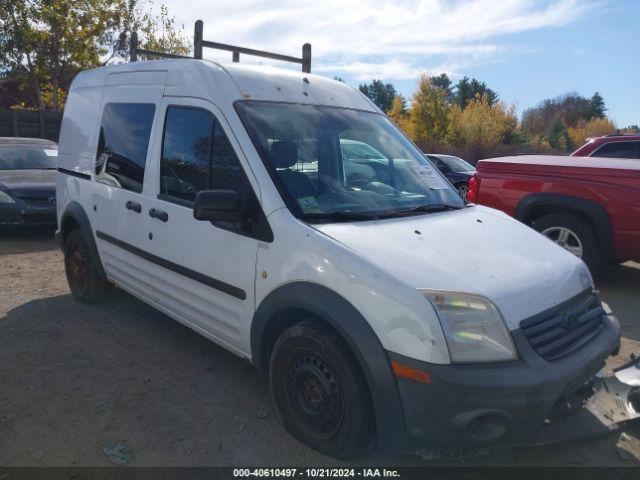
[0,0,189,110]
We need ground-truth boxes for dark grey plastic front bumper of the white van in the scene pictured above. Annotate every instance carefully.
[389,315,620,453]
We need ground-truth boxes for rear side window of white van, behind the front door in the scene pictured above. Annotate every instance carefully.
[95,103,156,193]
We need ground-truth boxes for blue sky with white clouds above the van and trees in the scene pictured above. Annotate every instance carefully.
[160,0,640,128]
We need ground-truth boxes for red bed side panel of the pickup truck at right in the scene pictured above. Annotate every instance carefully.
[477,167,640,260]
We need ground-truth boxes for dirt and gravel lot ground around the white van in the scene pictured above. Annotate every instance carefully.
[0,227,640,466]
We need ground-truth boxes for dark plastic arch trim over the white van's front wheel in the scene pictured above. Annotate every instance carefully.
[251,282,408,450]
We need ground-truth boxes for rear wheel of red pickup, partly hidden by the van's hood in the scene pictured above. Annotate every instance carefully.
[533,213,601,273]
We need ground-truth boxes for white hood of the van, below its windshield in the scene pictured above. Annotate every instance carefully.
[313,206,593,330]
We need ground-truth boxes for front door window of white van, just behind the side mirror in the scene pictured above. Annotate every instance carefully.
[160,107,215,202]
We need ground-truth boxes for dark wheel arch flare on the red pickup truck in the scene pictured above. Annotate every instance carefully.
[514,193,613,256]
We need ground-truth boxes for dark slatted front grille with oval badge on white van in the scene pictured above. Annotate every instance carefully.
[520,294,604,361]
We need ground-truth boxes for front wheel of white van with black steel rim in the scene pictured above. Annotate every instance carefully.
[269,321,375,459]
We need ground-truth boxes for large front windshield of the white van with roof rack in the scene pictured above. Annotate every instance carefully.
[236,101,464,221]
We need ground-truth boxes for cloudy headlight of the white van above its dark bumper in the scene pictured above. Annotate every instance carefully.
[420,290,518,363]
